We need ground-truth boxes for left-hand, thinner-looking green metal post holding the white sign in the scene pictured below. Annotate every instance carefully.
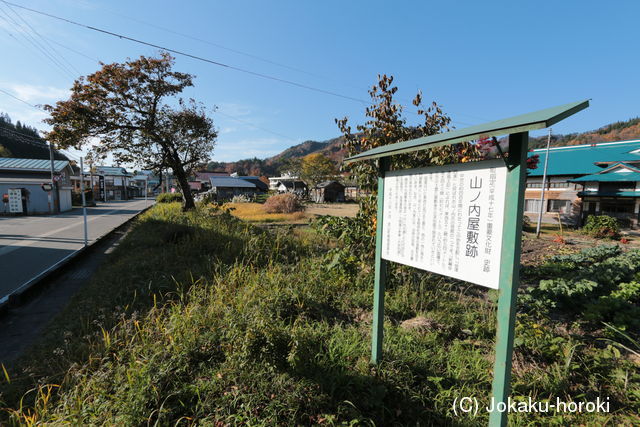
[371,157,389,364]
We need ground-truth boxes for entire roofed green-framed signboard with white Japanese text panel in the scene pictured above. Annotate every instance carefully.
[345,100,589,426]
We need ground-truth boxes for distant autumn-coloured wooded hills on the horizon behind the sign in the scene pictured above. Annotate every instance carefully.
[208,118,640,176]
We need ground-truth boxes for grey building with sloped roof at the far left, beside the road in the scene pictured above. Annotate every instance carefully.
[0,157,73,215]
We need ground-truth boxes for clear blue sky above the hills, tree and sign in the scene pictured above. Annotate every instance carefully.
[0,0,640,161]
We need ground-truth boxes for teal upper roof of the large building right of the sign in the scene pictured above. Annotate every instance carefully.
[529,139,640,176]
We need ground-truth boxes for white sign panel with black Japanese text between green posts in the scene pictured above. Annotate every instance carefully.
[382,159,507,289]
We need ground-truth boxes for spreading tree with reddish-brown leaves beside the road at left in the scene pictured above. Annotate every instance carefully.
[45,53,217,210]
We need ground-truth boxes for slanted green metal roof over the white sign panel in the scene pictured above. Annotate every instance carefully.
[344,100,589,163]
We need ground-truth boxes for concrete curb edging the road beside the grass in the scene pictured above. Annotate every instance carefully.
[0,204,154,316]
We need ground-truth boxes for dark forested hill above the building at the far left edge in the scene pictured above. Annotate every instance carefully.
[0,113,69,160]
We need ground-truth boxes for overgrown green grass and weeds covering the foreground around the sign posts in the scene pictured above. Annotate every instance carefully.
[0,204,640,426]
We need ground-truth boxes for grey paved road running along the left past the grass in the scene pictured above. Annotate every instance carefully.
[0,200,153,302]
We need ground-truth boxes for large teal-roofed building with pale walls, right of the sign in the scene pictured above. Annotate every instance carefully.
[524,140,640,224]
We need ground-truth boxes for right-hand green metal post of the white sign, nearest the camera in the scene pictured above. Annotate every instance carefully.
[489,132,529,427]
